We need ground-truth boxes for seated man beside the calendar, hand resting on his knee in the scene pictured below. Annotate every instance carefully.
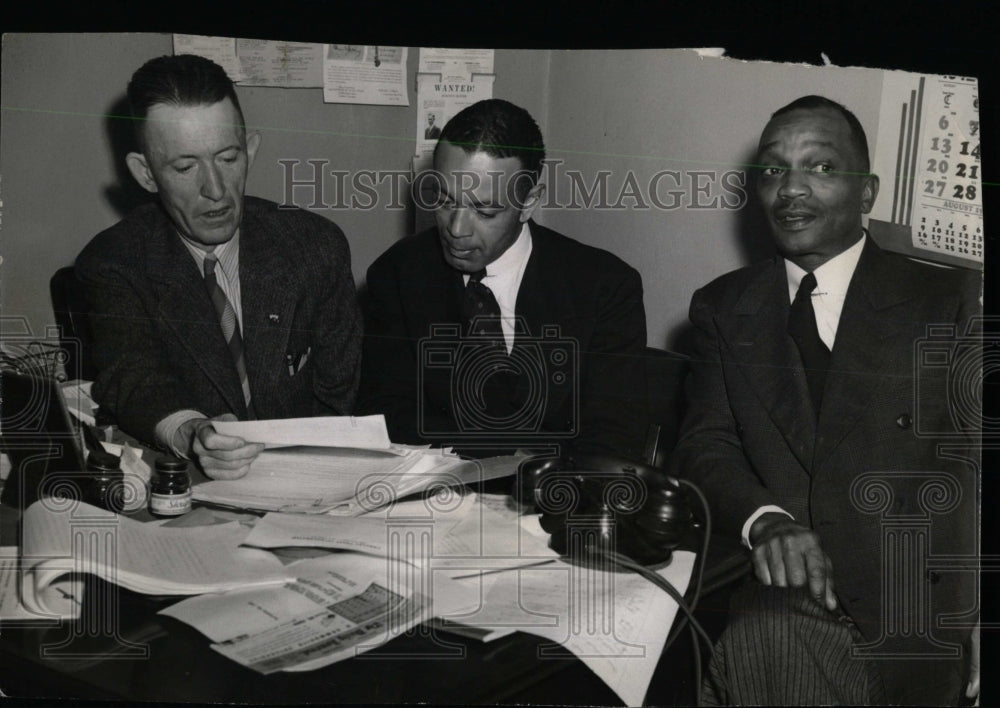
[673,96,981,705]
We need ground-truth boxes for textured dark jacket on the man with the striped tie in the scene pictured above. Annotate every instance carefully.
[76,197,361,443]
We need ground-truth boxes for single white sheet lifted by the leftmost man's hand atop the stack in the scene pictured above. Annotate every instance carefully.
[212,414,392,451]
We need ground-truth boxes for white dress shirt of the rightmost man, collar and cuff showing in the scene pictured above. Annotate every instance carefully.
[742,232,866,548]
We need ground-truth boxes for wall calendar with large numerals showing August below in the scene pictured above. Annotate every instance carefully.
[869,72,983,268]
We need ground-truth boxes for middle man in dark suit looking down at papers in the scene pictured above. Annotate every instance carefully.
[359,99,646,457]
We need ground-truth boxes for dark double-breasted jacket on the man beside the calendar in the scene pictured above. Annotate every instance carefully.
[673,238,981,703]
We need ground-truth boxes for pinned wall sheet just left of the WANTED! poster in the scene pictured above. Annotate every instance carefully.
[323,44,410,106]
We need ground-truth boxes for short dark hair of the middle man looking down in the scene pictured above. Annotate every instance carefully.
[434,98,545,199]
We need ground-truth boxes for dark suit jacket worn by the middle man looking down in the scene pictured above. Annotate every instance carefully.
[358,222,646,464]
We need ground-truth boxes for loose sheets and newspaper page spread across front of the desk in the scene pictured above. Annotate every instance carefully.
[162,495,694,705]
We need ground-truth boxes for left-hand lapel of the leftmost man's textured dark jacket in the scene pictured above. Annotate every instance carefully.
[149,219,246,414]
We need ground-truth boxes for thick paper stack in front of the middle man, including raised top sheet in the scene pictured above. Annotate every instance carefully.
[194,415,516,515]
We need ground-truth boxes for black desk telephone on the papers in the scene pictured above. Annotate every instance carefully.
[513,453,693,565]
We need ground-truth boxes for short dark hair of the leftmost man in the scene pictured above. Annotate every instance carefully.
[128,54,245,148]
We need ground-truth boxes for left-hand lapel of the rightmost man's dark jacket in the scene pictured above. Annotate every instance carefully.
[718,258,816,470]
